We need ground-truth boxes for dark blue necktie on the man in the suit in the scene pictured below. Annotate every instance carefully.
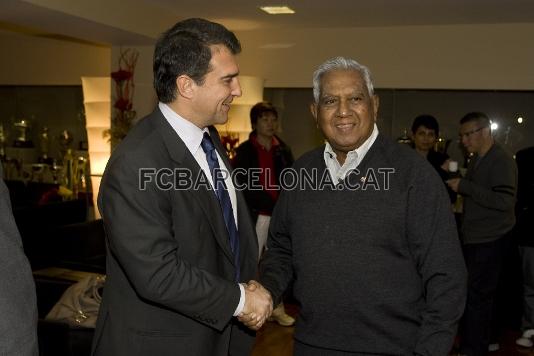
[200,132,239,282]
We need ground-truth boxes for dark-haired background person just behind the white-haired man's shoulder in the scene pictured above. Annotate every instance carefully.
[412,115,456,203]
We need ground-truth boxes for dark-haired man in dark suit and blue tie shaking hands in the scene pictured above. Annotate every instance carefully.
[93,19,272,356]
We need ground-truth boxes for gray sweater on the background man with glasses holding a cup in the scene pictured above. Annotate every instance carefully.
[458,143,517,244]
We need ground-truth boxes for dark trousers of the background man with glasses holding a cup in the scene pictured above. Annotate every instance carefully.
[460,237,505,356]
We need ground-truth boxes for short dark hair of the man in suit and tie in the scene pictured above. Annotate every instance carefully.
[153,18,241,103]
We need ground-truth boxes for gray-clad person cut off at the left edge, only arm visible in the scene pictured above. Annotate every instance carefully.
[0,164,38,356]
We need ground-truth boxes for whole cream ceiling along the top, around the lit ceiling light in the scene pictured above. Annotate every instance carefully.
[0,0,534,45]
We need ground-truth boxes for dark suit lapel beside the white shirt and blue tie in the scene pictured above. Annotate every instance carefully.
[155,109,238,264]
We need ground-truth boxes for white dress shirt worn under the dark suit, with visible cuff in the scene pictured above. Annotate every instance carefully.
[158,102,245,316]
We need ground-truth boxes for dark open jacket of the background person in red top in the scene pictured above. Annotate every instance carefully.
[232,132,294,223]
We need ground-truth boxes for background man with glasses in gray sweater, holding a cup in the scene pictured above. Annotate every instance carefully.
[447,112,517,356]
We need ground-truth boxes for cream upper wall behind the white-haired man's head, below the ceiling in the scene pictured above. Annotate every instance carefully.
[238,24,534,90]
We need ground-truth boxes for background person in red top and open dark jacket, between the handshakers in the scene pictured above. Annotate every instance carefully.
[233,102,295,326]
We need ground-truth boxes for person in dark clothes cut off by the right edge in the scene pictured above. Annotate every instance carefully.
[514,147,534,347]
